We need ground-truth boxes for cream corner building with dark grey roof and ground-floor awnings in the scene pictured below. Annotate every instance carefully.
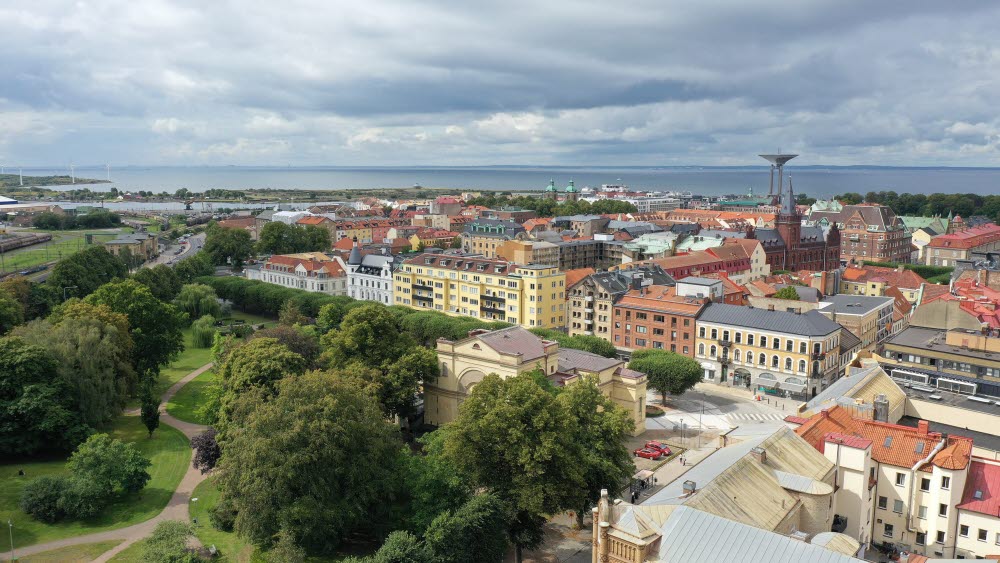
[694,303,841,398]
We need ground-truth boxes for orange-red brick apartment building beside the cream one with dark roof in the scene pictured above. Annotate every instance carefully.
[611,278,723,358]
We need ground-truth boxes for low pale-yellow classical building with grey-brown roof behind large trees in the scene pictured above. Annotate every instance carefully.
[424,327,646,435]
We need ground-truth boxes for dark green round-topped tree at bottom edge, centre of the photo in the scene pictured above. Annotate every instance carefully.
[424,493,508,563]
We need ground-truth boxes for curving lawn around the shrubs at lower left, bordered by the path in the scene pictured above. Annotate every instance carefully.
[0,416,191,548]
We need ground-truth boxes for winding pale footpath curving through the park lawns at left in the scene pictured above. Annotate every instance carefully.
[17,364,212,563]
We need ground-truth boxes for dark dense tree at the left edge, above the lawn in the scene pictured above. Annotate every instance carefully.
[0,337,91,455]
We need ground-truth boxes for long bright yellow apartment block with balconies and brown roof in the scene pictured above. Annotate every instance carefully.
[394,253,566,328]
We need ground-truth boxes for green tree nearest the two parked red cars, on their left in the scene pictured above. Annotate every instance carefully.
[556,378,632,528]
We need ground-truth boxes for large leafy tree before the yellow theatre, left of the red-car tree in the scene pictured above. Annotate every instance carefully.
[444,374,586,561]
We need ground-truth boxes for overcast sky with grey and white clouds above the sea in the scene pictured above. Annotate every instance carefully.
[0,0,1000,166]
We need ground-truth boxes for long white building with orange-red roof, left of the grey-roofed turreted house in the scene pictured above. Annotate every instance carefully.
[244,252,347,295]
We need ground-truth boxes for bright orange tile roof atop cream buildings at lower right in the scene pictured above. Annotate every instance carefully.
[795,405,972,469]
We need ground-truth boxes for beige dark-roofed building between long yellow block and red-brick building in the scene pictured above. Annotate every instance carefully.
[566,265,674,342]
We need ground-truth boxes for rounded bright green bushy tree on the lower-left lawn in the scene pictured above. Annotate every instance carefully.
[66,434,152,497]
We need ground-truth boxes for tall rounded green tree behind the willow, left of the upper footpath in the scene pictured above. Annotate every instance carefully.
[85,280,184,382]
